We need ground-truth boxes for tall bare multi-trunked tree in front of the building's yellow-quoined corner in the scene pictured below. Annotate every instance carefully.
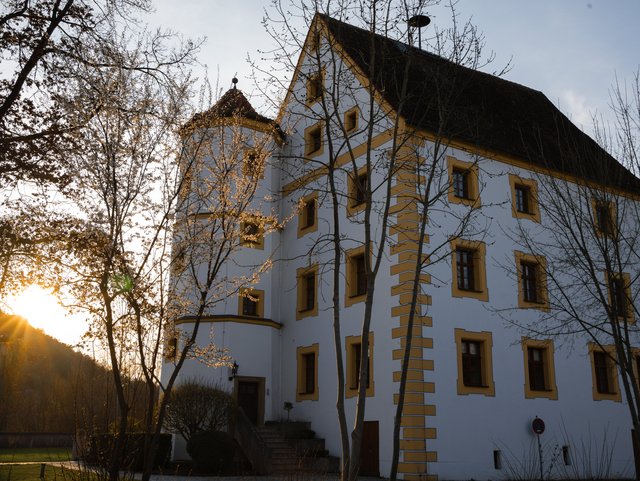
[258,1,502,479]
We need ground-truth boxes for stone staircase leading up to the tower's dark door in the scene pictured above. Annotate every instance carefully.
[256,422,339,474]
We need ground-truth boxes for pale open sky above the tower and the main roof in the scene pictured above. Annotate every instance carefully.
[148,0,640,132]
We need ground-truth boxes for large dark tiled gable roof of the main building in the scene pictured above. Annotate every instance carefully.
[320,15,640,193]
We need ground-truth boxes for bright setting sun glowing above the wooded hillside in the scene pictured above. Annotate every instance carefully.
[7,285,86,345]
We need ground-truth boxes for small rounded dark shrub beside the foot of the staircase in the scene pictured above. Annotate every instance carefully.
[187,431,236,474]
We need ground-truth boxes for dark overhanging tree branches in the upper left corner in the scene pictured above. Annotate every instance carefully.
[0,0,148,187]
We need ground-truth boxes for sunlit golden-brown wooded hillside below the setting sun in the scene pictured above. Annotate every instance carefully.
[0,312,143,433]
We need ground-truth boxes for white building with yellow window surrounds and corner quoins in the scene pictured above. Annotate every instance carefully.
[164,16,639,480]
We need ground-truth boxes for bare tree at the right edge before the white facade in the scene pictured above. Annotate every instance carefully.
[505,70,640,477]
